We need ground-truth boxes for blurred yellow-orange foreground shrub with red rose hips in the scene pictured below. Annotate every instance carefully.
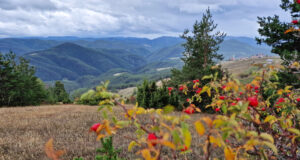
[81,63,300,160]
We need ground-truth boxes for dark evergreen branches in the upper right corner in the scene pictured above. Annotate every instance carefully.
[256,0,300,63]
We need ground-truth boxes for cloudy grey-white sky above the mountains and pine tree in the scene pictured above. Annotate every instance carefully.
[0,0,291,38]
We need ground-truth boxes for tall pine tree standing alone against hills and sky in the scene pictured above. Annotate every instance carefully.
[171,9,225,85]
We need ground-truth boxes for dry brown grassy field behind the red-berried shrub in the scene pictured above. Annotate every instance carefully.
[0,105,217,160]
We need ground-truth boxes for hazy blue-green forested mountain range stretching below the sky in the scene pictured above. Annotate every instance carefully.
[0,36,271,91]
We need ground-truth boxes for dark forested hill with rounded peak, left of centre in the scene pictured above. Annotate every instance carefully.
[24,42,146,81]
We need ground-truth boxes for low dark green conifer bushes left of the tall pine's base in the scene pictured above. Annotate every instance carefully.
[136,80,181,109]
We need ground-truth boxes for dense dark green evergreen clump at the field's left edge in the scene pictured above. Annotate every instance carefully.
[0,52,46,106]
